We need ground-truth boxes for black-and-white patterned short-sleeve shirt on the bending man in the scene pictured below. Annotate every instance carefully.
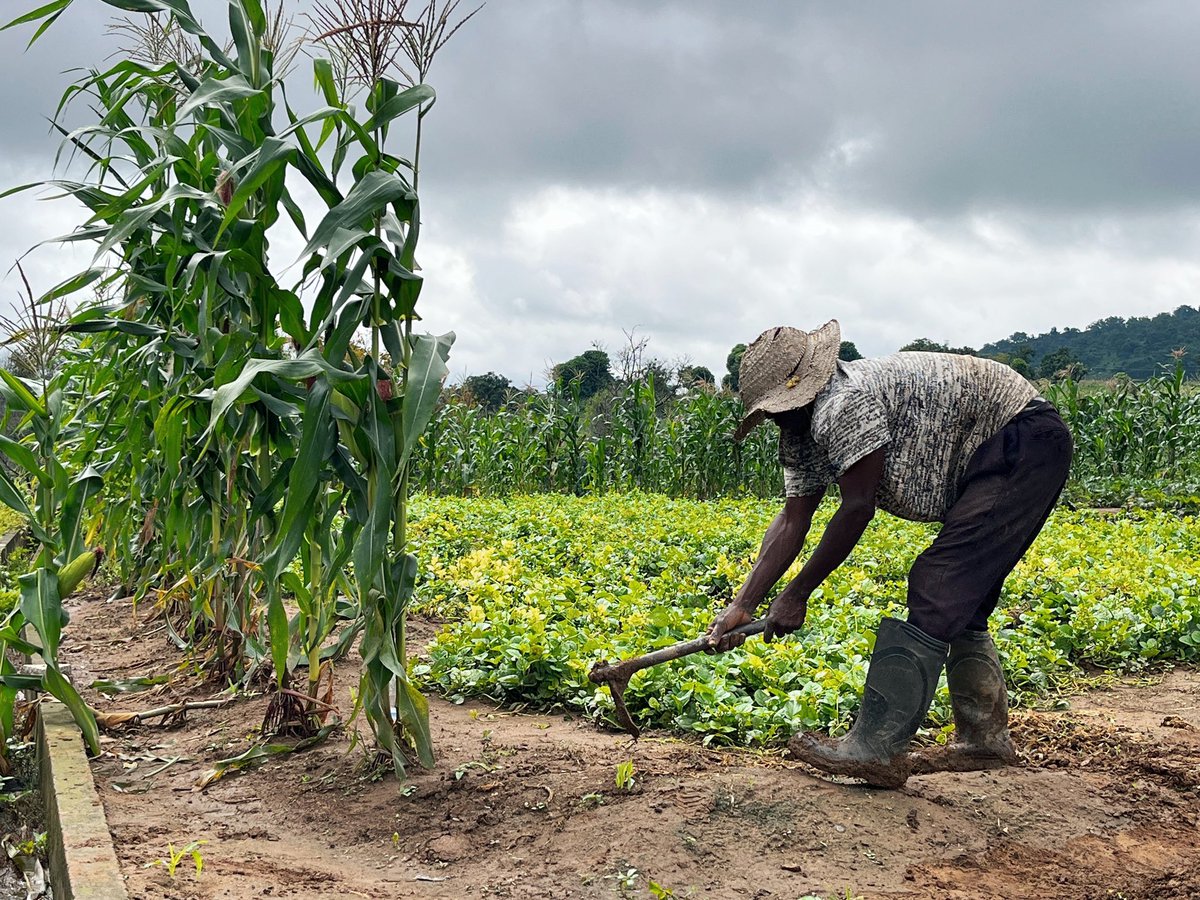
[779,353,1037,522]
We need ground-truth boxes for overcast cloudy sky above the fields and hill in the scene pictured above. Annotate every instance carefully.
[0,0,1200,385]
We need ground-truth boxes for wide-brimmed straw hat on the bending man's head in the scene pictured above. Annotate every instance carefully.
[733,319,841,440]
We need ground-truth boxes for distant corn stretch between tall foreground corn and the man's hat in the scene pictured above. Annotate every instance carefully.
[415,382,782,498]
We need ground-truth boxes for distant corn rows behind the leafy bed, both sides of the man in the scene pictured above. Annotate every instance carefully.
[413,366,1200,508]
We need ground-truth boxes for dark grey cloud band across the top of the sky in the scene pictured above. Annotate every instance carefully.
[415,0,1200,215]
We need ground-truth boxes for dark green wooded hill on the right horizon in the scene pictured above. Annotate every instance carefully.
[979,306,1200,379]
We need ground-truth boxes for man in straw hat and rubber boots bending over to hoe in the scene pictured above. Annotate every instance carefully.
[708,322,1072,787]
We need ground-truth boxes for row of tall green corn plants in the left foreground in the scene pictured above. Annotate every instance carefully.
[10,0,474,772]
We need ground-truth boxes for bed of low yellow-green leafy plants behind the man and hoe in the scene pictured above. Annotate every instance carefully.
[413,493,1200,745]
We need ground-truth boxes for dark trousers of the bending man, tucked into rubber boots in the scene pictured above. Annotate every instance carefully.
[908,402,1073,641]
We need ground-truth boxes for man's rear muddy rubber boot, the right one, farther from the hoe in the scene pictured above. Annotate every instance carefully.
[913,631,1016,774]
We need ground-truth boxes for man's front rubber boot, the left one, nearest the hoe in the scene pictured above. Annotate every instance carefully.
[787,619,948,787]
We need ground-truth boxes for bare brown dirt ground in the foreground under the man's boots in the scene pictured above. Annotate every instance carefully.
[51,595,1200,900]
